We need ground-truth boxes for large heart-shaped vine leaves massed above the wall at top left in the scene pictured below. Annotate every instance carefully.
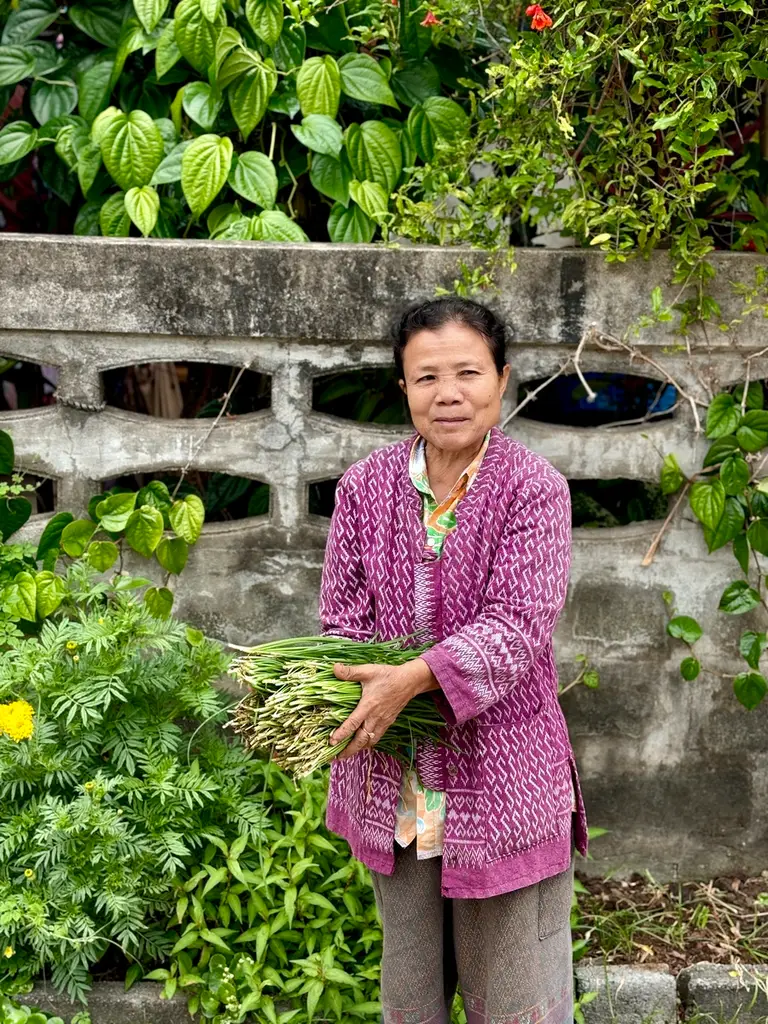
[0,0,484,242]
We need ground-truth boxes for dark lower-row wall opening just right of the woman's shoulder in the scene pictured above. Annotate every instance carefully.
[568,478,669,527]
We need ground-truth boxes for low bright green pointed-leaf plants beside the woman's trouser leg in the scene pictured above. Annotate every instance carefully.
[146,762,381,1024]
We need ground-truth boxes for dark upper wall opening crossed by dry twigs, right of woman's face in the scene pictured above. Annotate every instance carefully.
[517,371,677,427]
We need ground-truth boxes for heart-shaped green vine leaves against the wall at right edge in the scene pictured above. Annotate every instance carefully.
[660,381,768,711]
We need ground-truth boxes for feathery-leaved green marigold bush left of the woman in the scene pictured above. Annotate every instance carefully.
[0,562,274,998]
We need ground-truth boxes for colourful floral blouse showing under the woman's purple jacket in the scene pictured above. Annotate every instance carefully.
[394,431,490,860]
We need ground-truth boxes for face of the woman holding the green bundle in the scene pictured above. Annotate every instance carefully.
[399,324,509,452]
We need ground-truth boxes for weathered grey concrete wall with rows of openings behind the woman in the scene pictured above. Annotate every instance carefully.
[0,234,768,879]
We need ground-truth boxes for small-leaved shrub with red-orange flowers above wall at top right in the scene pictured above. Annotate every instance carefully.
[395,0,768,292]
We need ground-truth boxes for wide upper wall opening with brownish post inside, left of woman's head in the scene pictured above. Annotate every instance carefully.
[101,362,272,420]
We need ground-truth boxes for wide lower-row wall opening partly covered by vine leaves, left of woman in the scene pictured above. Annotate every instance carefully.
[101,469,269,522]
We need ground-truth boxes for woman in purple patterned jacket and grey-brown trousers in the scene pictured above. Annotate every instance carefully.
[319,298,587,1024]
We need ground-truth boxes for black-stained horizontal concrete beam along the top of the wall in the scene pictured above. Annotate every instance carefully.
[0,234,761,348]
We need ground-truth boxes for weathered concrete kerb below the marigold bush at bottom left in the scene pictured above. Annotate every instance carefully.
[13,981,200,1024]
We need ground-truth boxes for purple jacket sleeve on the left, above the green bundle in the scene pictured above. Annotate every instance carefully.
[319,467,375,640]
